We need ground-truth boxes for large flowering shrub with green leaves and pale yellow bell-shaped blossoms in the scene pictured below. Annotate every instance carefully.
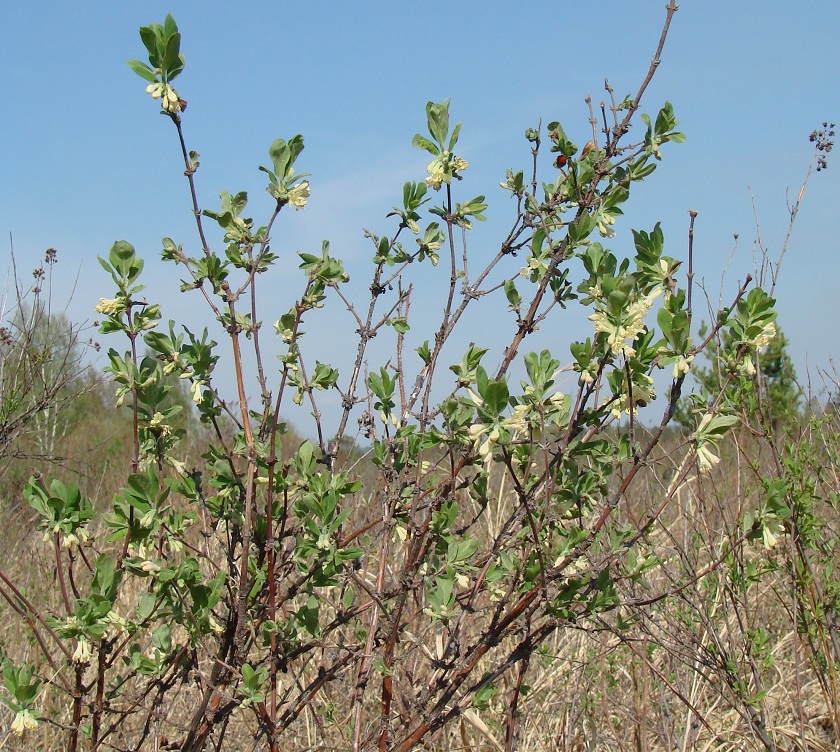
[2,3,820,750]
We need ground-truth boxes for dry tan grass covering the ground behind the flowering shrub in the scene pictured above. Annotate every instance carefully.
[0,412,840,752]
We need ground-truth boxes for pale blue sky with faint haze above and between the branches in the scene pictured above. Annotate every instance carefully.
[0,0,840,432]
